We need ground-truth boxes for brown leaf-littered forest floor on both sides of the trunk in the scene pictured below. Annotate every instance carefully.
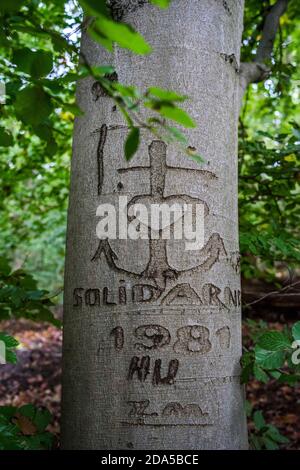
[0,320,300,450]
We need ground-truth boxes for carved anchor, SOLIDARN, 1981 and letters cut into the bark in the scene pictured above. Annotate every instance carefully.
[78,129,241,426]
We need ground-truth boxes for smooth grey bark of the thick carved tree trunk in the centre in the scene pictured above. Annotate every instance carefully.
[62,0,247,449]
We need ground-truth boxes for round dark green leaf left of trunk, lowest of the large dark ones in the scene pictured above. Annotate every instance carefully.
[14,86,52,126]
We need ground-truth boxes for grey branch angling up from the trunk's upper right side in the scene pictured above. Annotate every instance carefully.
[239,0,288,102]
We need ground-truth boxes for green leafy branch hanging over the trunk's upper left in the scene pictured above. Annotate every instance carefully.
[0,0,203,163]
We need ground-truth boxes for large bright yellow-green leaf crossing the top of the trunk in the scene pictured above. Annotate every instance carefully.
[89,15,151,54]
